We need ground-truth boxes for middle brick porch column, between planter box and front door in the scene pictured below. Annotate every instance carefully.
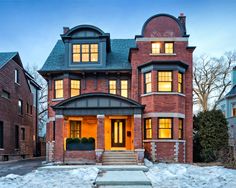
[96,115,105,163]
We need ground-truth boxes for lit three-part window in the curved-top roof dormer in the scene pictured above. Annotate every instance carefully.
[72,44,98,63]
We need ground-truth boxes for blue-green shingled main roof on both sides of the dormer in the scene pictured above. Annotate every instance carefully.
[39,39,136,72]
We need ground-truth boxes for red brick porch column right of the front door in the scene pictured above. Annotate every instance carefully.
[134,114,144,163]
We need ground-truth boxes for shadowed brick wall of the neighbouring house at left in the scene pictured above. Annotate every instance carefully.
[0,55,37,160]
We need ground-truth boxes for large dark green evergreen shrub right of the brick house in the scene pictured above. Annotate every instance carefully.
[193,110,228,162]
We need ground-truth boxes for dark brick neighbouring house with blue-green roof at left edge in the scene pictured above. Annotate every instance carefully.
[0,52,40,160]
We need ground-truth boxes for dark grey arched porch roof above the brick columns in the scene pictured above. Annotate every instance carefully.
[52,93,144,116]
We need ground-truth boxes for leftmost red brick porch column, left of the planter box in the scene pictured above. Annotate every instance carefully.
[54,115,64,163]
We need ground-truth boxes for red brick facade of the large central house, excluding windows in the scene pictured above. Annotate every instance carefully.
[44,14,194,163]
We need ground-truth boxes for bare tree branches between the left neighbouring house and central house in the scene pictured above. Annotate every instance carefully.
[26,64,47,135]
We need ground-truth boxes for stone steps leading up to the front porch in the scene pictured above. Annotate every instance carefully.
[102,151,137,165]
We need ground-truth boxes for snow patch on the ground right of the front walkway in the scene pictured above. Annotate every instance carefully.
[145,160,236,188]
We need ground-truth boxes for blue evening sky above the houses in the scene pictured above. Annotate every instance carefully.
[0,0,236,68]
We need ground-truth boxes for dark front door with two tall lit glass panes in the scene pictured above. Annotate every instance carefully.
[111,119,125,147]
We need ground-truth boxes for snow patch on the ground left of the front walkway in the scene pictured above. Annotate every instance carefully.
[0,167,99,188]
